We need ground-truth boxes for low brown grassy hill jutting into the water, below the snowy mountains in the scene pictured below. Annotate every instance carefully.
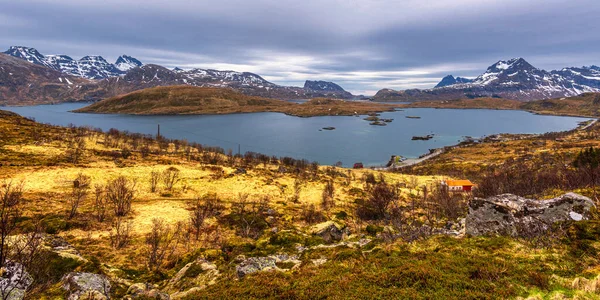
[77,86,394,117]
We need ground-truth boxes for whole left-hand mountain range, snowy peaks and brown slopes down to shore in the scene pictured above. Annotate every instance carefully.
[0,46,355,104]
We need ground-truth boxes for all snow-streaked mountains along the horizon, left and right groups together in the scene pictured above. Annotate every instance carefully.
[0,46,600,104]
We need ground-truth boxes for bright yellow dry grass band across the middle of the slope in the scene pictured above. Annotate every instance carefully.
[12,161,441,233]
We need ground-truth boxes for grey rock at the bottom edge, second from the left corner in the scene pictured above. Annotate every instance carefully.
[62,272,110,300]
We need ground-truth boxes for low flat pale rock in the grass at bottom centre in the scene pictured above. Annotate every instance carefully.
[235,254,302,277]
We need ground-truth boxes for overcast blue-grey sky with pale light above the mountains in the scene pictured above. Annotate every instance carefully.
[0,0,600,95]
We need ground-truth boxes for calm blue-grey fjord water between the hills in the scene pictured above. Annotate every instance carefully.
[0,103,588,166]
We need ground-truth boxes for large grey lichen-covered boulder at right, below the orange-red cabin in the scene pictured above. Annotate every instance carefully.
[465,193,594,237]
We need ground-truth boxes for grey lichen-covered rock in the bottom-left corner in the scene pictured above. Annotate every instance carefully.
[0,261,33,300]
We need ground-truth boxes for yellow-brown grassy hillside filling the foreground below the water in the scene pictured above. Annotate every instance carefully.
[0,110,600,299]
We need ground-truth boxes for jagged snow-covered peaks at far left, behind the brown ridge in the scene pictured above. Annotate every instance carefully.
[4,46,142,79]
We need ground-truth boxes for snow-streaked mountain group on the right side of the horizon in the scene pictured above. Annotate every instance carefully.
[373,58,600,101]
